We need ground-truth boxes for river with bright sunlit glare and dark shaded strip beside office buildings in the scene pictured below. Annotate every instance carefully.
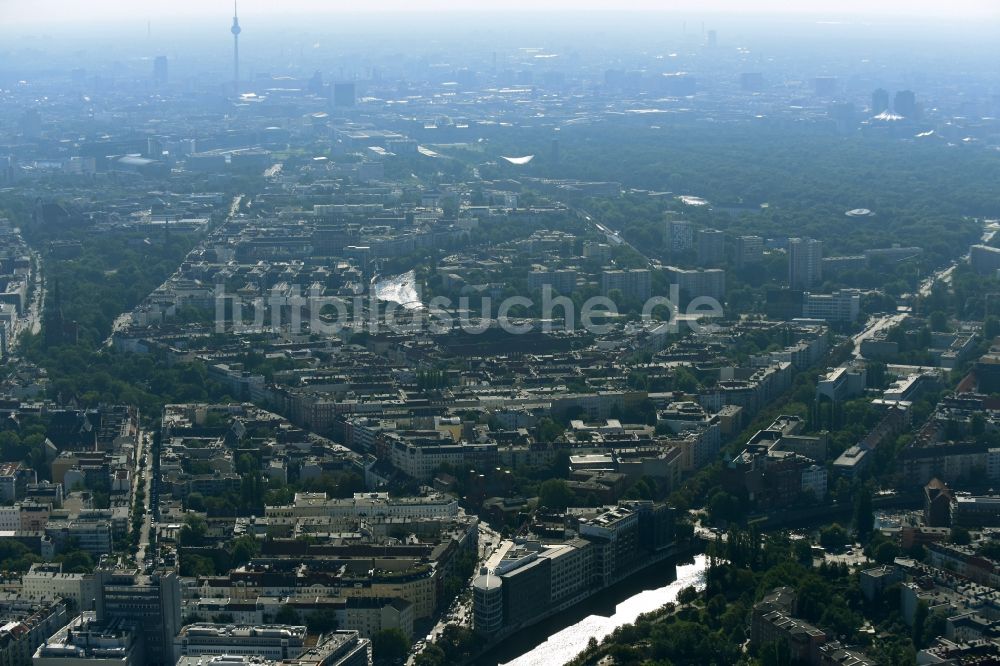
[477,555,708,666]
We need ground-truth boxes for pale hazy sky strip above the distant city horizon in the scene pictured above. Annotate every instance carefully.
[0,0,1000,25]
